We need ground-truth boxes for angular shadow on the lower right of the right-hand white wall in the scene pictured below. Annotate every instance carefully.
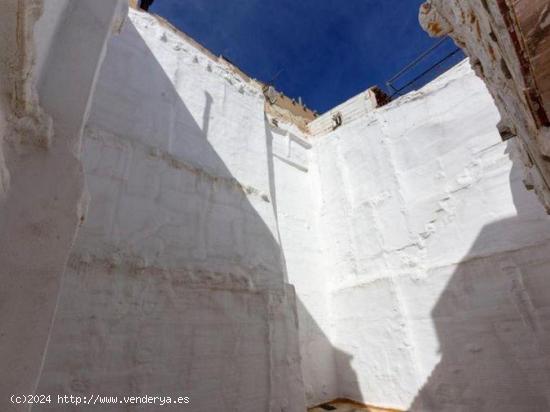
[410,149,550,412]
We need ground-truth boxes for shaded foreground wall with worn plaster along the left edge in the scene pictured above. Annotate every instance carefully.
[0,0,128,411]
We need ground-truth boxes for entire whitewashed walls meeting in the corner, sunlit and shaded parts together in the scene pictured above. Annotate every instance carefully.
[23,7,550,412]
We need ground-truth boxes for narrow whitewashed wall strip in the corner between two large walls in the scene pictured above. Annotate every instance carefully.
[267,122,338,405]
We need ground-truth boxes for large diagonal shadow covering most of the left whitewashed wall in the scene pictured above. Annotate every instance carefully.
[33,16,312,412]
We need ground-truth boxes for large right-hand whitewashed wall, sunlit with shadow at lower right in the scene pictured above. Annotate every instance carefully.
[314,63,550,412]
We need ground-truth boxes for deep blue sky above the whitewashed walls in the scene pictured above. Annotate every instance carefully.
[150,0,464,113]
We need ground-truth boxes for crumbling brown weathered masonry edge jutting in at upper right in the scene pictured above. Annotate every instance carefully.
[420,0,550,210]
